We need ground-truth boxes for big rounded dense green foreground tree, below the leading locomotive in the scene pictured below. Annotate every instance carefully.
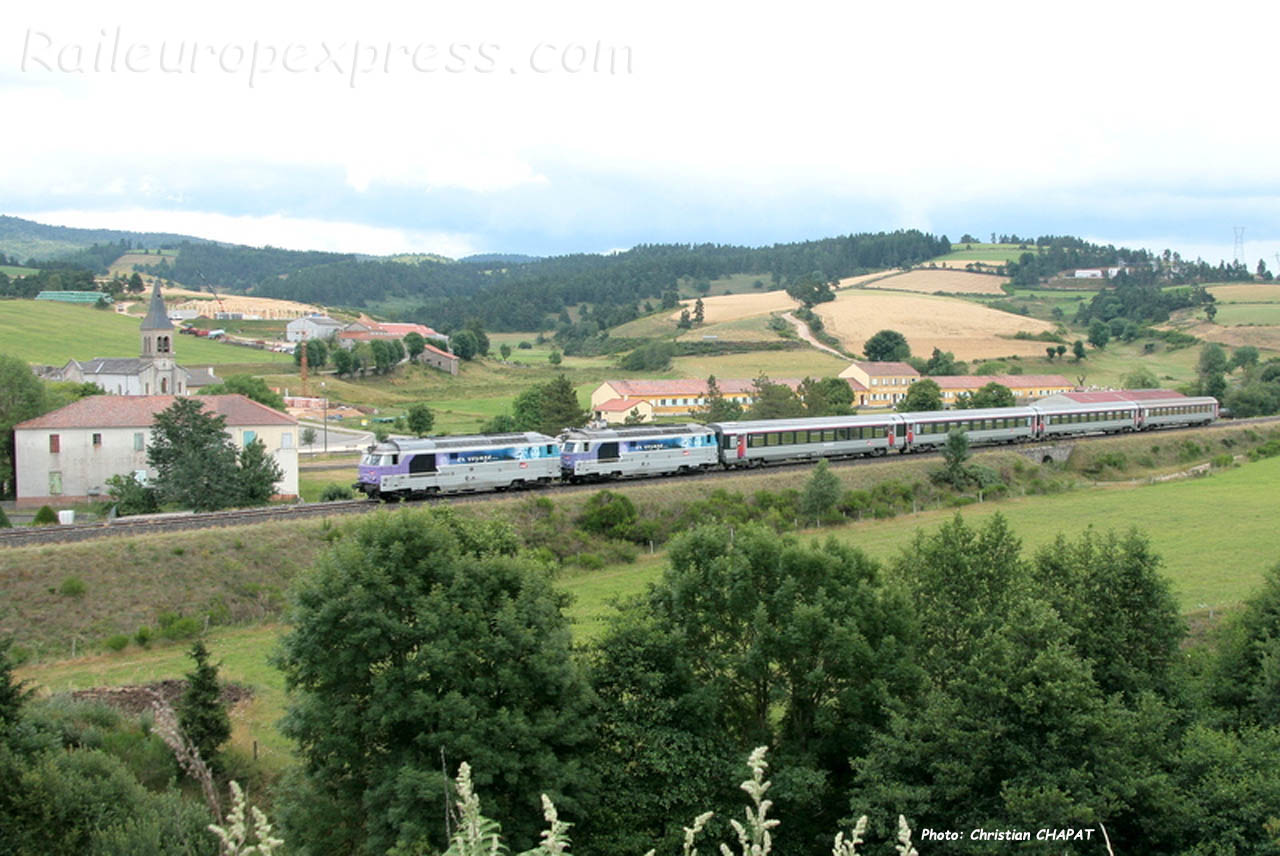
[279,509,594,853]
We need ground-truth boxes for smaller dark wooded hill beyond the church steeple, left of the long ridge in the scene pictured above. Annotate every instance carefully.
[141,241,358,294]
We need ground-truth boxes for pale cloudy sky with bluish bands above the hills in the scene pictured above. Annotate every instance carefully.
[0,0,1280,270]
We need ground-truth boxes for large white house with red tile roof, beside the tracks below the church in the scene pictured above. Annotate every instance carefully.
[14,395,298,507]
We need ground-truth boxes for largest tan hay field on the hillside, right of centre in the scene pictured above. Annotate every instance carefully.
[815,290,1053,360]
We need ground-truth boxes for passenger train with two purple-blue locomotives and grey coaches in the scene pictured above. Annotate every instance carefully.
[353,390,1219,500]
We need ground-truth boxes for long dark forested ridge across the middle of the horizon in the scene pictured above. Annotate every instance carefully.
[253,230,951,330]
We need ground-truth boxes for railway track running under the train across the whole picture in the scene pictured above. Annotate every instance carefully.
[0,416,1280,548]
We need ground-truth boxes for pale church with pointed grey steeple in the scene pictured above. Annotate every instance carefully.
[52,281,221,395]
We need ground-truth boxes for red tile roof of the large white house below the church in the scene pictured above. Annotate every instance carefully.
[14,395,298,431]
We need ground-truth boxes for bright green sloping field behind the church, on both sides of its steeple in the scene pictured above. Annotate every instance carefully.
[0,301,293,374]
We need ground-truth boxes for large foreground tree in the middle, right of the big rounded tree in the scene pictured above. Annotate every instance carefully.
[595,525,919,853]
